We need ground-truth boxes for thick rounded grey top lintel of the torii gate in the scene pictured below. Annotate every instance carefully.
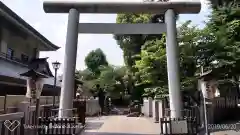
[43,0,201,14]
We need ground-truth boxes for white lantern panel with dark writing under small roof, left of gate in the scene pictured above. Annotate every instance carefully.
[26,78,43,99]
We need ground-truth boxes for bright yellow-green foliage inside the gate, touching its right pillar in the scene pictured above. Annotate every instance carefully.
[136,36,167,86]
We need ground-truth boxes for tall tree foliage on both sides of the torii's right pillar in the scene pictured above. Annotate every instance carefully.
[115,1,240,95]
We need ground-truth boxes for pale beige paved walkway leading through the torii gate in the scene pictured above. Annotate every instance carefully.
[83,116,160,135]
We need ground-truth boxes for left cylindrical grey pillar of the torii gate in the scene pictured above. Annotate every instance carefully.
[59,8,80,117]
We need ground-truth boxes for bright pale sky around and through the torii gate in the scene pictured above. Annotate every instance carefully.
[1,0,210,72]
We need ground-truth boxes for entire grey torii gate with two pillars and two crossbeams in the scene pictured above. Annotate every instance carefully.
[43,0,201,118]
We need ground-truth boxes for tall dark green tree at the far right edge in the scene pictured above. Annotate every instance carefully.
[200,0,240,94]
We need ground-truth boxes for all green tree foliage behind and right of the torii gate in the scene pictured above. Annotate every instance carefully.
[76,0,240,99]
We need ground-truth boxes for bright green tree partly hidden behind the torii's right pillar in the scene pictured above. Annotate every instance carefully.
[136,21,201,94]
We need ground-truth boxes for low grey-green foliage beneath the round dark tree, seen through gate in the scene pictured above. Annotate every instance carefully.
[76,65,127,97]
